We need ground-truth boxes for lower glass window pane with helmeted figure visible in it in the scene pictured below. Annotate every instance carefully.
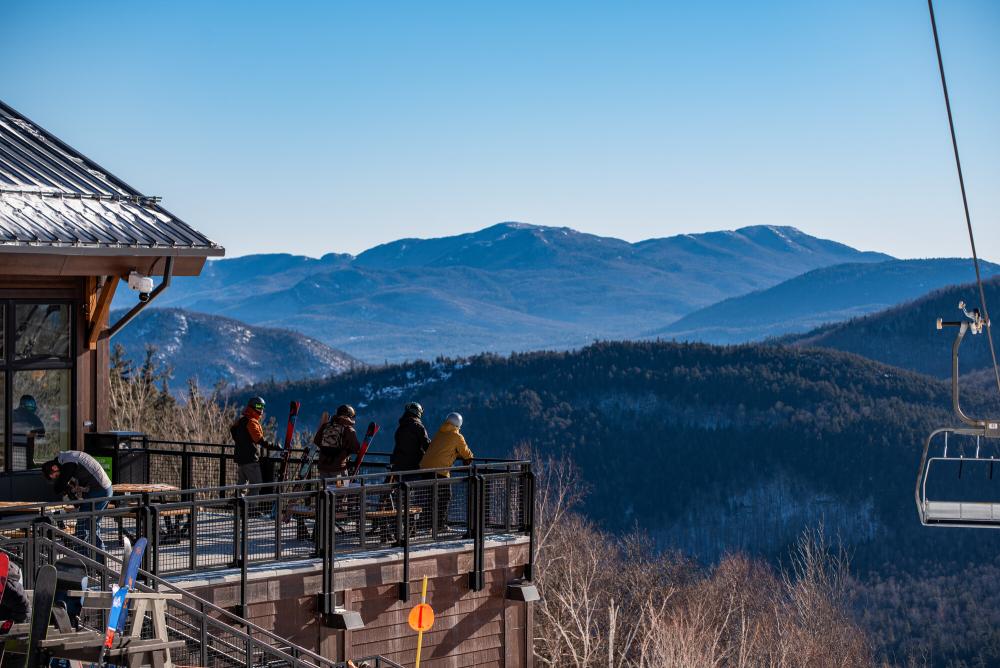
[11,370,71,470]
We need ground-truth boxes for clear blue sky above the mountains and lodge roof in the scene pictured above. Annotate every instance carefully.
[0,0,1000,260]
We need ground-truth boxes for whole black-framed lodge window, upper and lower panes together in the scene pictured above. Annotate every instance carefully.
[0,300,73,471]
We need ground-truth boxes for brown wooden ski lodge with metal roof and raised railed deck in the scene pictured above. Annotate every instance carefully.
[0,102,537,668]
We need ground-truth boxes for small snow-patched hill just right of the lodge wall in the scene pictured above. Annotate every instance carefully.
[112,308,359,392]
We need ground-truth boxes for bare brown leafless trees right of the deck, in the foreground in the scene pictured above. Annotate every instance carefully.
[534,458,875,668]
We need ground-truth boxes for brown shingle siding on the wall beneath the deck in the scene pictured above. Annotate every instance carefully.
[178,542,533,668]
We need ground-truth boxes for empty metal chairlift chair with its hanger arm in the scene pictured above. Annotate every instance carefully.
[914,302,1000,529]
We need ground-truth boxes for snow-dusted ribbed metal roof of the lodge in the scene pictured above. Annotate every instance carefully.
[0,102,225,257]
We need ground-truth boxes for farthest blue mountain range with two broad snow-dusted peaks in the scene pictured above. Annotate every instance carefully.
[116,223,891,363]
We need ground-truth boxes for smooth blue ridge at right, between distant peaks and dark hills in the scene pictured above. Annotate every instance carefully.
[649,258,1000,344]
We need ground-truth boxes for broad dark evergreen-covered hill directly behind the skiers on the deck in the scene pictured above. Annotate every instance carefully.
[252,343,1000,568]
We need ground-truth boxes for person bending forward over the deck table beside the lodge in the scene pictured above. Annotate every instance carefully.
[42,450,114,550]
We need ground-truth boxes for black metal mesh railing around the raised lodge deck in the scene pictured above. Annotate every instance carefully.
[0,440,534,613]
